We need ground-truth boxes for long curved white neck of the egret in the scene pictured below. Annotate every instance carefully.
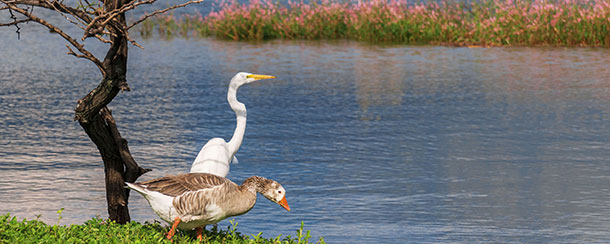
[227,82,247,155]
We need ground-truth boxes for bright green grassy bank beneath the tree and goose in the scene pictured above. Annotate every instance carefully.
[0,214,324,244]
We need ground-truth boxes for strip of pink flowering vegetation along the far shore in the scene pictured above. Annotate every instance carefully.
[143,0,610,47]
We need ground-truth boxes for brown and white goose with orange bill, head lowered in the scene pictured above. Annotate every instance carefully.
[126,173,290,240]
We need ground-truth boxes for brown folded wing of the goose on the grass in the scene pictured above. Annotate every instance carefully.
[136,173,231,197]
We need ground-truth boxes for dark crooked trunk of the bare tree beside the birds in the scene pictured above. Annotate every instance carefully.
[76,0,148,224]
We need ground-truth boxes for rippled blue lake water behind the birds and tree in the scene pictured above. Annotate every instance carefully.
[0,25,610,243]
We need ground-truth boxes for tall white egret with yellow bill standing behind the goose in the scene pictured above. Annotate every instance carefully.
[190,72,275,177]
